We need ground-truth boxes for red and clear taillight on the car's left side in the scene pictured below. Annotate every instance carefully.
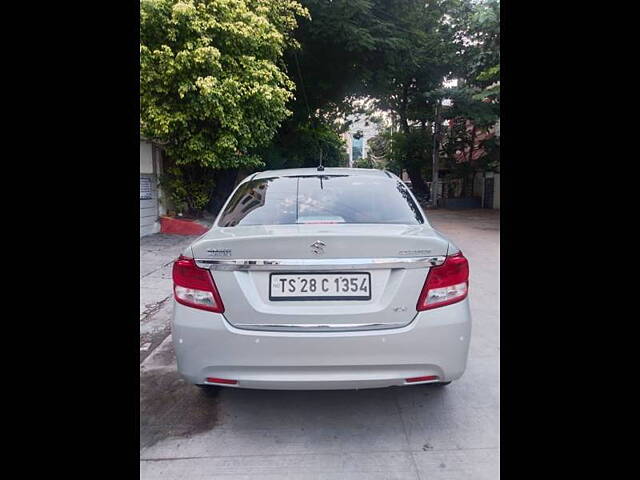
[173,255,224,313]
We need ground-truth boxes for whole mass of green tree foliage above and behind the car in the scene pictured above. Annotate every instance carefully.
[141,0,500,212]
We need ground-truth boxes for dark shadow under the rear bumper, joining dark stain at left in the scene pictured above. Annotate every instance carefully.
[140,367,448,450]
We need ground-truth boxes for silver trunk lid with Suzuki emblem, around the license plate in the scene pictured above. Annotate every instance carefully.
[192,224,448,331]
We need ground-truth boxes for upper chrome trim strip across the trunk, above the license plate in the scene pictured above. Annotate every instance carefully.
[196,255,446,271]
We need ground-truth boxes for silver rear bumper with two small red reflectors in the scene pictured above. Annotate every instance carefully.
[172,299,471,390]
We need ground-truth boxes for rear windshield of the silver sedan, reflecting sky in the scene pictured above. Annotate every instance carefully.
[218,175,424,227]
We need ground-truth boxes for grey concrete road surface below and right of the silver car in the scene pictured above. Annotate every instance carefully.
[140,210,500,480]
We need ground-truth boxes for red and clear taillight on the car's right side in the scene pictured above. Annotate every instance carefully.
[416,252,469,312]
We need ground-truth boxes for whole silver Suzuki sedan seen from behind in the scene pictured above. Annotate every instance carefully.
[172,168,471,390]
